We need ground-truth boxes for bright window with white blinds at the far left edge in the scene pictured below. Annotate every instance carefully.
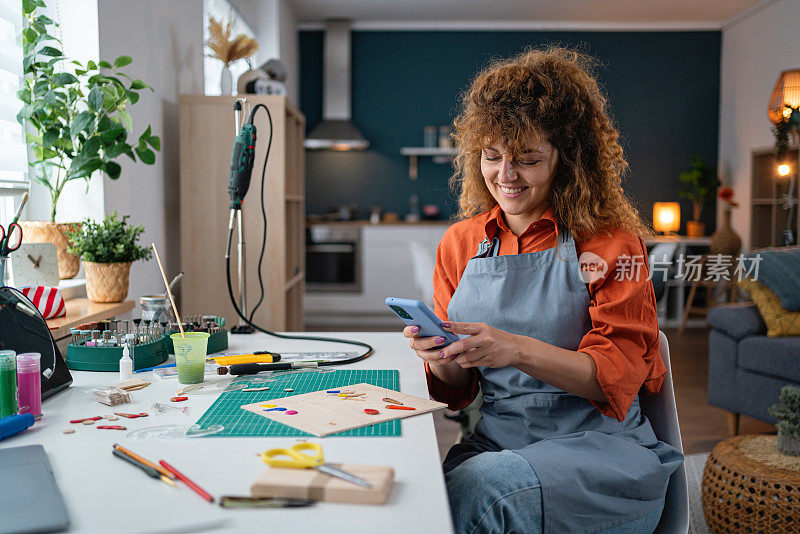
[0,0,29,223]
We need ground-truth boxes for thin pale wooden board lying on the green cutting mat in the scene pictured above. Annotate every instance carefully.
[242,383,447,437]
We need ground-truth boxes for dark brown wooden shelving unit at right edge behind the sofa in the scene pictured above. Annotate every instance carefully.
[750,147,800,249]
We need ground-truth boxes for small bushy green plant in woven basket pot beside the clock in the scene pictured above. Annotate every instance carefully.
[67,212,151,302]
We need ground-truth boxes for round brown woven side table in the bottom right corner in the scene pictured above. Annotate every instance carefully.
[702,434,800,534]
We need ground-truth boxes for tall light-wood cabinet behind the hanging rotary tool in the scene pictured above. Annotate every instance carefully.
[179,95,305,331]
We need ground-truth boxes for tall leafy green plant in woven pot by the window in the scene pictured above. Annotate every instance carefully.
[17,0,161,279]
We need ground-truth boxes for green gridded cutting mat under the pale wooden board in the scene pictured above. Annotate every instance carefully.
[197,369,400,437]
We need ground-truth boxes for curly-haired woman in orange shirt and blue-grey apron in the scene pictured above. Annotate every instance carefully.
[404,48,683,533]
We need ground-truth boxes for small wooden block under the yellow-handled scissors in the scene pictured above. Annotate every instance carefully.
[250,464,399,504]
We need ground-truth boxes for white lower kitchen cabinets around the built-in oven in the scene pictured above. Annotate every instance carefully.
[304,223,447,328]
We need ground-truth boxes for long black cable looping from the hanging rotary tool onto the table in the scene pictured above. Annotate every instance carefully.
[225,104,374,367]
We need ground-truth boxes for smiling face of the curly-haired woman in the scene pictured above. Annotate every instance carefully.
[481,139,558,235]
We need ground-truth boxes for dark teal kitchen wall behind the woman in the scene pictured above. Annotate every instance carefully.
[300,31,721,231]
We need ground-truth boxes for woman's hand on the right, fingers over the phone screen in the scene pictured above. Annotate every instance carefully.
[442,321,521,369]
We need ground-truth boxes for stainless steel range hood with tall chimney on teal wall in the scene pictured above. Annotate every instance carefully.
[303,20,369,150]
